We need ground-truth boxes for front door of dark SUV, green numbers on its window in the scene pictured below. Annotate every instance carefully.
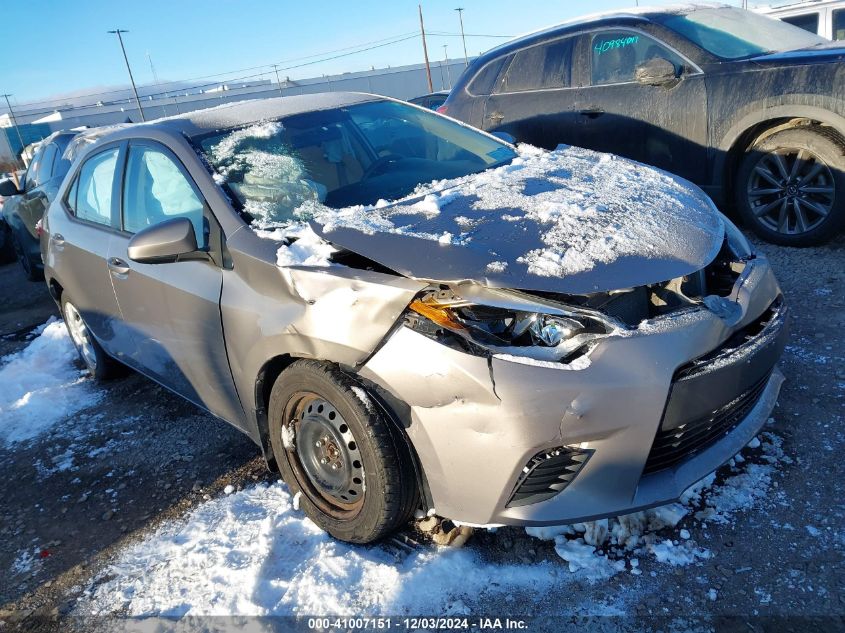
[580,28,708,182]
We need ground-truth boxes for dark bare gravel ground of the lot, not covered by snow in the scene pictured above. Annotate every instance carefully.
[0,231,845,631]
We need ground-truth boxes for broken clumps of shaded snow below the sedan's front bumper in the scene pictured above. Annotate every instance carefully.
[525,433,791,578]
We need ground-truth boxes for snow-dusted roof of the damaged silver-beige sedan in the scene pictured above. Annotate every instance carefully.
[132,92,385,137]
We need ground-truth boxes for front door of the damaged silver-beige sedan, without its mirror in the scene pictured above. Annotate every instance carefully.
[109,141,243,421]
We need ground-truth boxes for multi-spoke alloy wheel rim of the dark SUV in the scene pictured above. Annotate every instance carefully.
[747,149,836,235]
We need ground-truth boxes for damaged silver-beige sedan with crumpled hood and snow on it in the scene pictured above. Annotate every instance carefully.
[42,93,786,543]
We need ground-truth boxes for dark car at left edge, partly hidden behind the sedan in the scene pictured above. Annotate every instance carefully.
[0,132,77,281]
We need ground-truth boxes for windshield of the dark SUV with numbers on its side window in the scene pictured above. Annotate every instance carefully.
[656,7,826,59]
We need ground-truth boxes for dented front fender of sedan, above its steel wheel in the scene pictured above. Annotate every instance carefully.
[220,230,426,438]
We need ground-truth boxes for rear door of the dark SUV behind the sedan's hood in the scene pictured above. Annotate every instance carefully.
[483,36,579,149]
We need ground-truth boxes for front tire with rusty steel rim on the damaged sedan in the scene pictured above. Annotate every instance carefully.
[268,360,418,543]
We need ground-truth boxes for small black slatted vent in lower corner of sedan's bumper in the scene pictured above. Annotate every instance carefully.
[507,446,593,508]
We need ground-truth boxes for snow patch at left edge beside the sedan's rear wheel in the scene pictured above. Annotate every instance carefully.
[0,318,102,444]
